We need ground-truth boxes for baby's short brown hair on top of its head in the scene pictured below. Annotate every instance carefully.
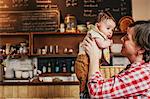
[97,11,116,23]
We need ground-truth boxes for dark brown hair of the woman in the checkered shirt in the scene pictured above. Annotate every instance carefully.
[129,21,150,62]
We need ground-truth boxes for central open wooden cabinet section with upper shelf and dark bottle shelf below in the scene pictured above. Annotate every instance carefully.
[31,32,86,76]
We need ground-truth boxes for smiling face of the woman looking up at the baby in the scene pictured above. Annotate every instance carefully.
[121,27,139,59]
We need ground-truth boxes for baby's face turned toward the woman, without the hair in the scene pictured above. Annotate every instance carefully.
[97,19,116,38]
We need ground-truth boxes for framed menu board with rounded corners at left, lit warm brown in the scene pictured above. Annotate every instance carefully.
[0,10,60,32]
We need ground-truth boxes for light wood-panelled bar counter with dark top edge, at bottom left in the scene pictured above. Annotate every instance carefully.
[0,82,79,99]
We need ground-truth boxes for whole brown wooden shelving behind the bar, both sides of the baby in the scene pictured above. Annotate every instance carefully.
[0,32,124,81]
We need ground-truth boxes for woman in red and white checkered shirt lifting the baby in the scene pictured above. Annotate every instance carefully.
[84,21,150,99]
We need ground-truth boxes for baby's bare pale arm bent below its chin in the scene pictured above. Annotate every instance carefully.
[95,38,113,48]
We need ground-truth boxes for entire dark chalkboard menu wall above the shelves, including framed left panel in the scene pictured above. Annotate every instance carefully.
[0,0,132,32]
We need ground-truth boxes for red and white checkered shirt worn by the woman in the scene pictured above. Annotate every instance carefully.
[88,61,150,99]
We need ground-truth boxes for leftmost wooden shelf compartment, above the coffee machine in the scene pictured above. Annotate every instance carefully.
[0,33,31,56]
